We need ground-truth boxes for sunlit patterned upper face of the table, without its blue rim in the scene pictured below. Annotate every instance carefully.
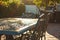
[0,18,38,31]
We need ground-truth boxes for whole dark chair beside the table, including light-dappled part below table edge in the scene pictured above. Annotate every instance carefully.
[14,13,50,40]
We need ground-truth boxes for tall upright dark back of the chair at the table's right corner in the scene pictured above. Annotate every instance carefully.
[31,12,50,40]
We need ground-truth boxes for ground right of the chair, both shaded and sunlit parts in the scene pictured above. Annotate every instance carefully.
[46,23,60,40]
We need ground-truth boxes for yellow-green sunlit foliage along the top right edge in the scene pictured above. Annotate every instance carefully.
[33,0,60,7]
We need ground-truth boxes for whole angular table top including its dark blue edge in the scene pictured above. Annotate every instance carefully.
[0,18,38,35]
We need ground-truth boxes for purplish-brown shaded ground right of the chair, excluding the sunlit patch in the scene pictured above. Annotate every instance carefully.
[47,23,60,40]
